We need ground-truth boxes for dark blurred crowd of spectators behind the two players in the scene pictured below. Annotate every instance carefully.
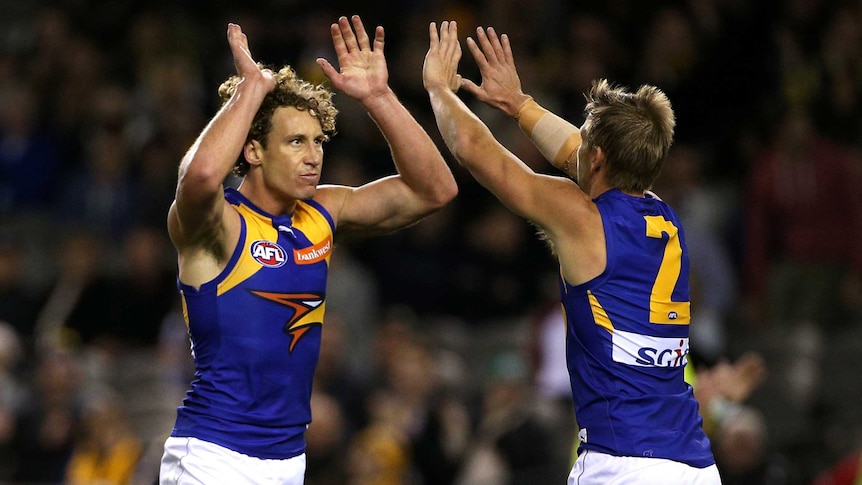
[0,0,862,485]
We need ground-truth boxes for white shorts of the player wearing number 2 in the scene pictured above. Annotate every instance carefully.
[568,450,721,485]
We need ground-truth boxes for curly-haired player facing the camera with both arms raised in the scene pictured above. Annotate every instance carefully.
[165,16,458,485]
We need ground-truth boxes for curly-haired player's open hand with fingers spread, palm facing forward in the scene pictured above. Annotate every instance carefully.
[317,15,389,102]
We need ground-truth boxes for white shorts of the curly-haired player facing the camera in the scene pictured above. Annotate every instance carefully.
[159,436,305,485]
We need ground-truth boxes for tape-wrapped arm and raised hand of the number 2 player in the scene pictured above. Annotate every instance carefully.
[462,27,581,178]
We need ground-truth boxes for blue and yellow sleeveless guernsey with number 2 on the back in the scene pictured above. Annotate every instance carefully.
[560,190,715,468]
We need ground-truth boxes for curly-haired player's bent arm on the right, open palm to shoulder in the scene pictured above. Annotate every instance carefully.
[318,15,458,239]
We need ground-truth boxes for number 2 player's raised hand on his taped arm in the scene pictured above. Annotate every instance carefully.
[462,27,529,116]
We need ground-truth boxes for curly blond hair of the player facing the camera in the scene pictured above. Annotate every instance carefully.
[218,63,338,177]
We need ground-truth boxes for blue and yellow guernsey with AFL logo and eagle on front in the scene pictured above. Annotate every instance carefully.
[171,188,335,459]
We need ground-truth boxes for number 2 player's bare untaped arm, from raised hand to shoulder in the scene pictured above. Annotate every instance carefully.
[430,22,605,284]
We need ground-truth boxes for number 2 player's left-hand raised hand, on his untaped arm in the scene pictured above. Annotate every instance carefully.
[422,20,461,92]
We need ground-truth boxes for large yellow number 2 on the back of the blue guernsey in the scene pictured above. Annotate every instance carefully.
[644,216,691,325]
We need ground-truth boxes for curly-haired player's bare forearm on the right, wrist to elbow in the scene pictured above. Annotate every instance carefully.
[363,90,457,203]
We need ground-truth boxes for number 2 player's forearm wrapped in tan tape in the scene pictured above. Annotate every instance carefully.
[514,98,581,175]
